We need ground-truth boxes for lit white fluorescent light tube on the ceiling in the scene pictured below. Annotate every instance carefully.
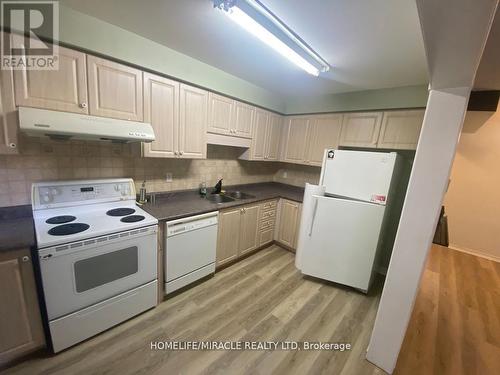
[224,6,319,77]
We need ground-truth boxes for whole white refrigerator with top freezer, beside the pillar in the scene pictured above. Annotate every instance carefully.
[295,150,401,292]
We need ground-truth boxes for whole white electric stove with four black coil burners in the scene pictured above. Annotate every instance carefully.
[32,179,158,352]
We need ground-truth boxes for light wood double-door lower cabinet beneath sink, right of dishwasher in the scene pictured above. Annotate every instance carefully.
[216,204,260,266]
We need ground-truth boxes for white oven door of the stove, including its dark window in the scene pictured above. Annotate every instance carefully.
[39,226,157,320]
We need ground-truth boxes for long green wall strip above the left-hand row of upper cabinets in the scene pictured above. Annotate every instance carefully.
[54,4,285,112]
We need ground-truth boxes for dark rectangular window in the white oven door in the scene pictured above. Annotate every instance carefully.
[74,246,139,293]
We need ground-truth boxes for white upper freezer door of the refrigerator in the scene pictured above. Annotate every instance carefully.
[322,150,397,204]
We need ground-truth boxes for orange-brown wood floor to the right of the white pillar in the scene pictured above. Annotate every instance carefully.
[394,245,500,375]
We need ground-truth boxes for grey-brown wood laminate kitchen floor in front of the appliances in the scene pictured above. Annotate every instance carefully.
[6,246,383,375]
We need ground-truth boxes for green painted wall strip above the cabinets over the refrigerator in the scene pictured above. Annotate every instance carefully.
[285,85,428,114]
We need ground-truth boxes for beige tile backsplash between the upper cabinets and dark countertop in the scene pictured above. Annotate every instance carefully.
[0,136,319,206]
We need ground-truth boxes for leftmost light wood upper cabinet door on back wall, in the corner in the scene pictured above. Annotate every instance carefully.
[283,117,309,164]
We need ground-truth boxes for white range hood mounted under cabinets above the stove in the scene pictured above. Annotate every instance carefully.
[19,107,155,143]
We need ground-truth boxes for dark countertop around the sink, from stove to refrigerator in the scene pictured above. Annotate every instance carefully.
[142,182,304,221]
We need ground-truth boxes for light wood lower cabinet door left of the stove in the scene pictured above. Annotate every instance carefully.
[0,249,45,368]
